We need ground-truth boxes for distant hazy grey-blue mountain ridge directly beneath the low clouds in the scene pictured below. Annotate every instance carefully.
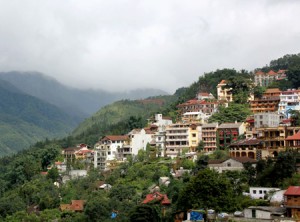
[0,71,168,119]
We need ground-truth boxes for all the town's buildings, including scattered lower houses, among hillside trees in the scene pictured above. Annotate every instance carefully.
[47,70,300,221]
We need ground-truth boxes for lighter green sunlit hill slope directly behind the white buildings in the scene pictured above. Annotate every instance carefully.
[67,96,177,145]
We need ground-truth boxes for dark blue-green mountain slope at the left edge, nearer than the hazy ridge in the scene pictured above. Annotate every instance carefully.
[0,80,79,156]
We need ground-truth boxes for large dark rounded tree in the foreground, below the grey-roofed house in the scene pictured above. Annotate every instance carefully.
[177,169,236,212]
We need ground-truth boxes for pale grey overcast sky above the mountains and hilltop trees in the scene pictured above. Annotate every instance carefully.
[0,0,300,93]
